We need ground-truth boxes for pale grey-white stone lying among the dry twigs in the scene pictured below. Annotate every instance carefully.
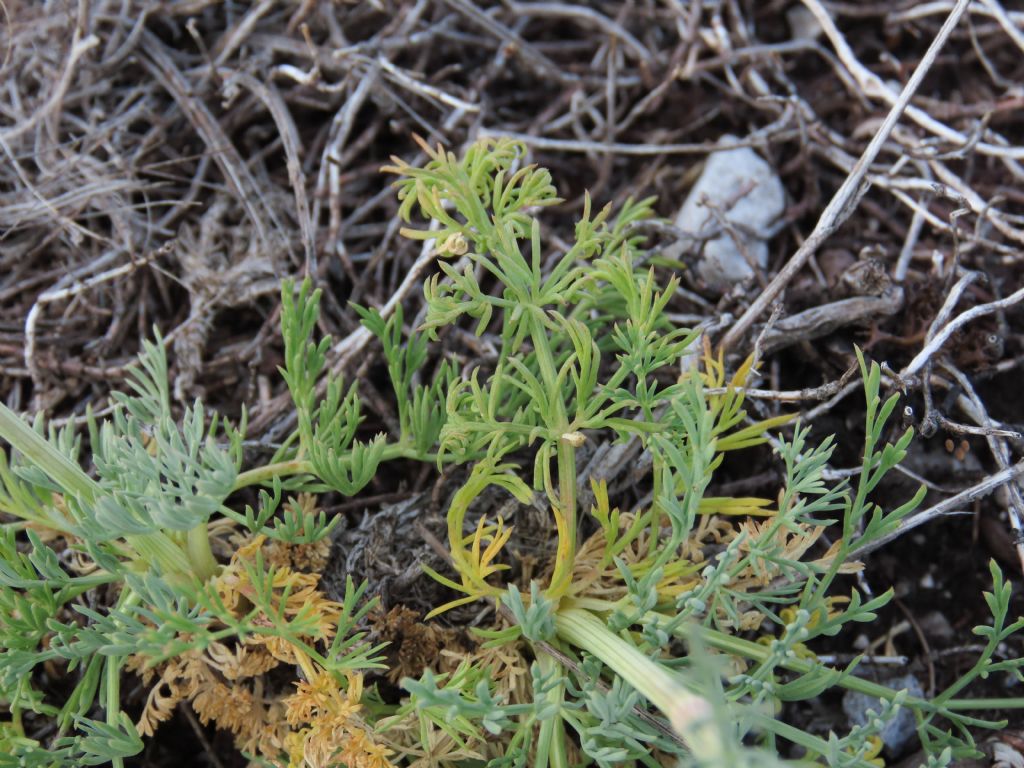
[676,136,785,293]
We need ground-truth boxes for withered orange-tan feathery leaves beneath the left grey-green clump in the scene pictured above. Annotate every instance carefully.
[128,536,390,768]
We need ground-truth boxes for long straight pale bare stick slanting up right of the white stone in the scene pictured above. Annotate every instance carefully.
[722,0,971,347]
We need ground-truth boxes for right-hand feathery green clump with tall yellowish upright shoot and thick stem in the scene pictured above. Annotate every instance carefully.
[364,140,1024,767]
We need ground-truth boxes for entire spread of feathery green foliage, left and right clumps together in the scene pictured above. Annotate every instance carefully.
[0,140,1024,768]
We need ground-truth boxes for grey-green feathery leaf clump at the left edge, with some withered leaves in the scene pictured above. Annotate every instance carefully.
[0,337,387,766]
